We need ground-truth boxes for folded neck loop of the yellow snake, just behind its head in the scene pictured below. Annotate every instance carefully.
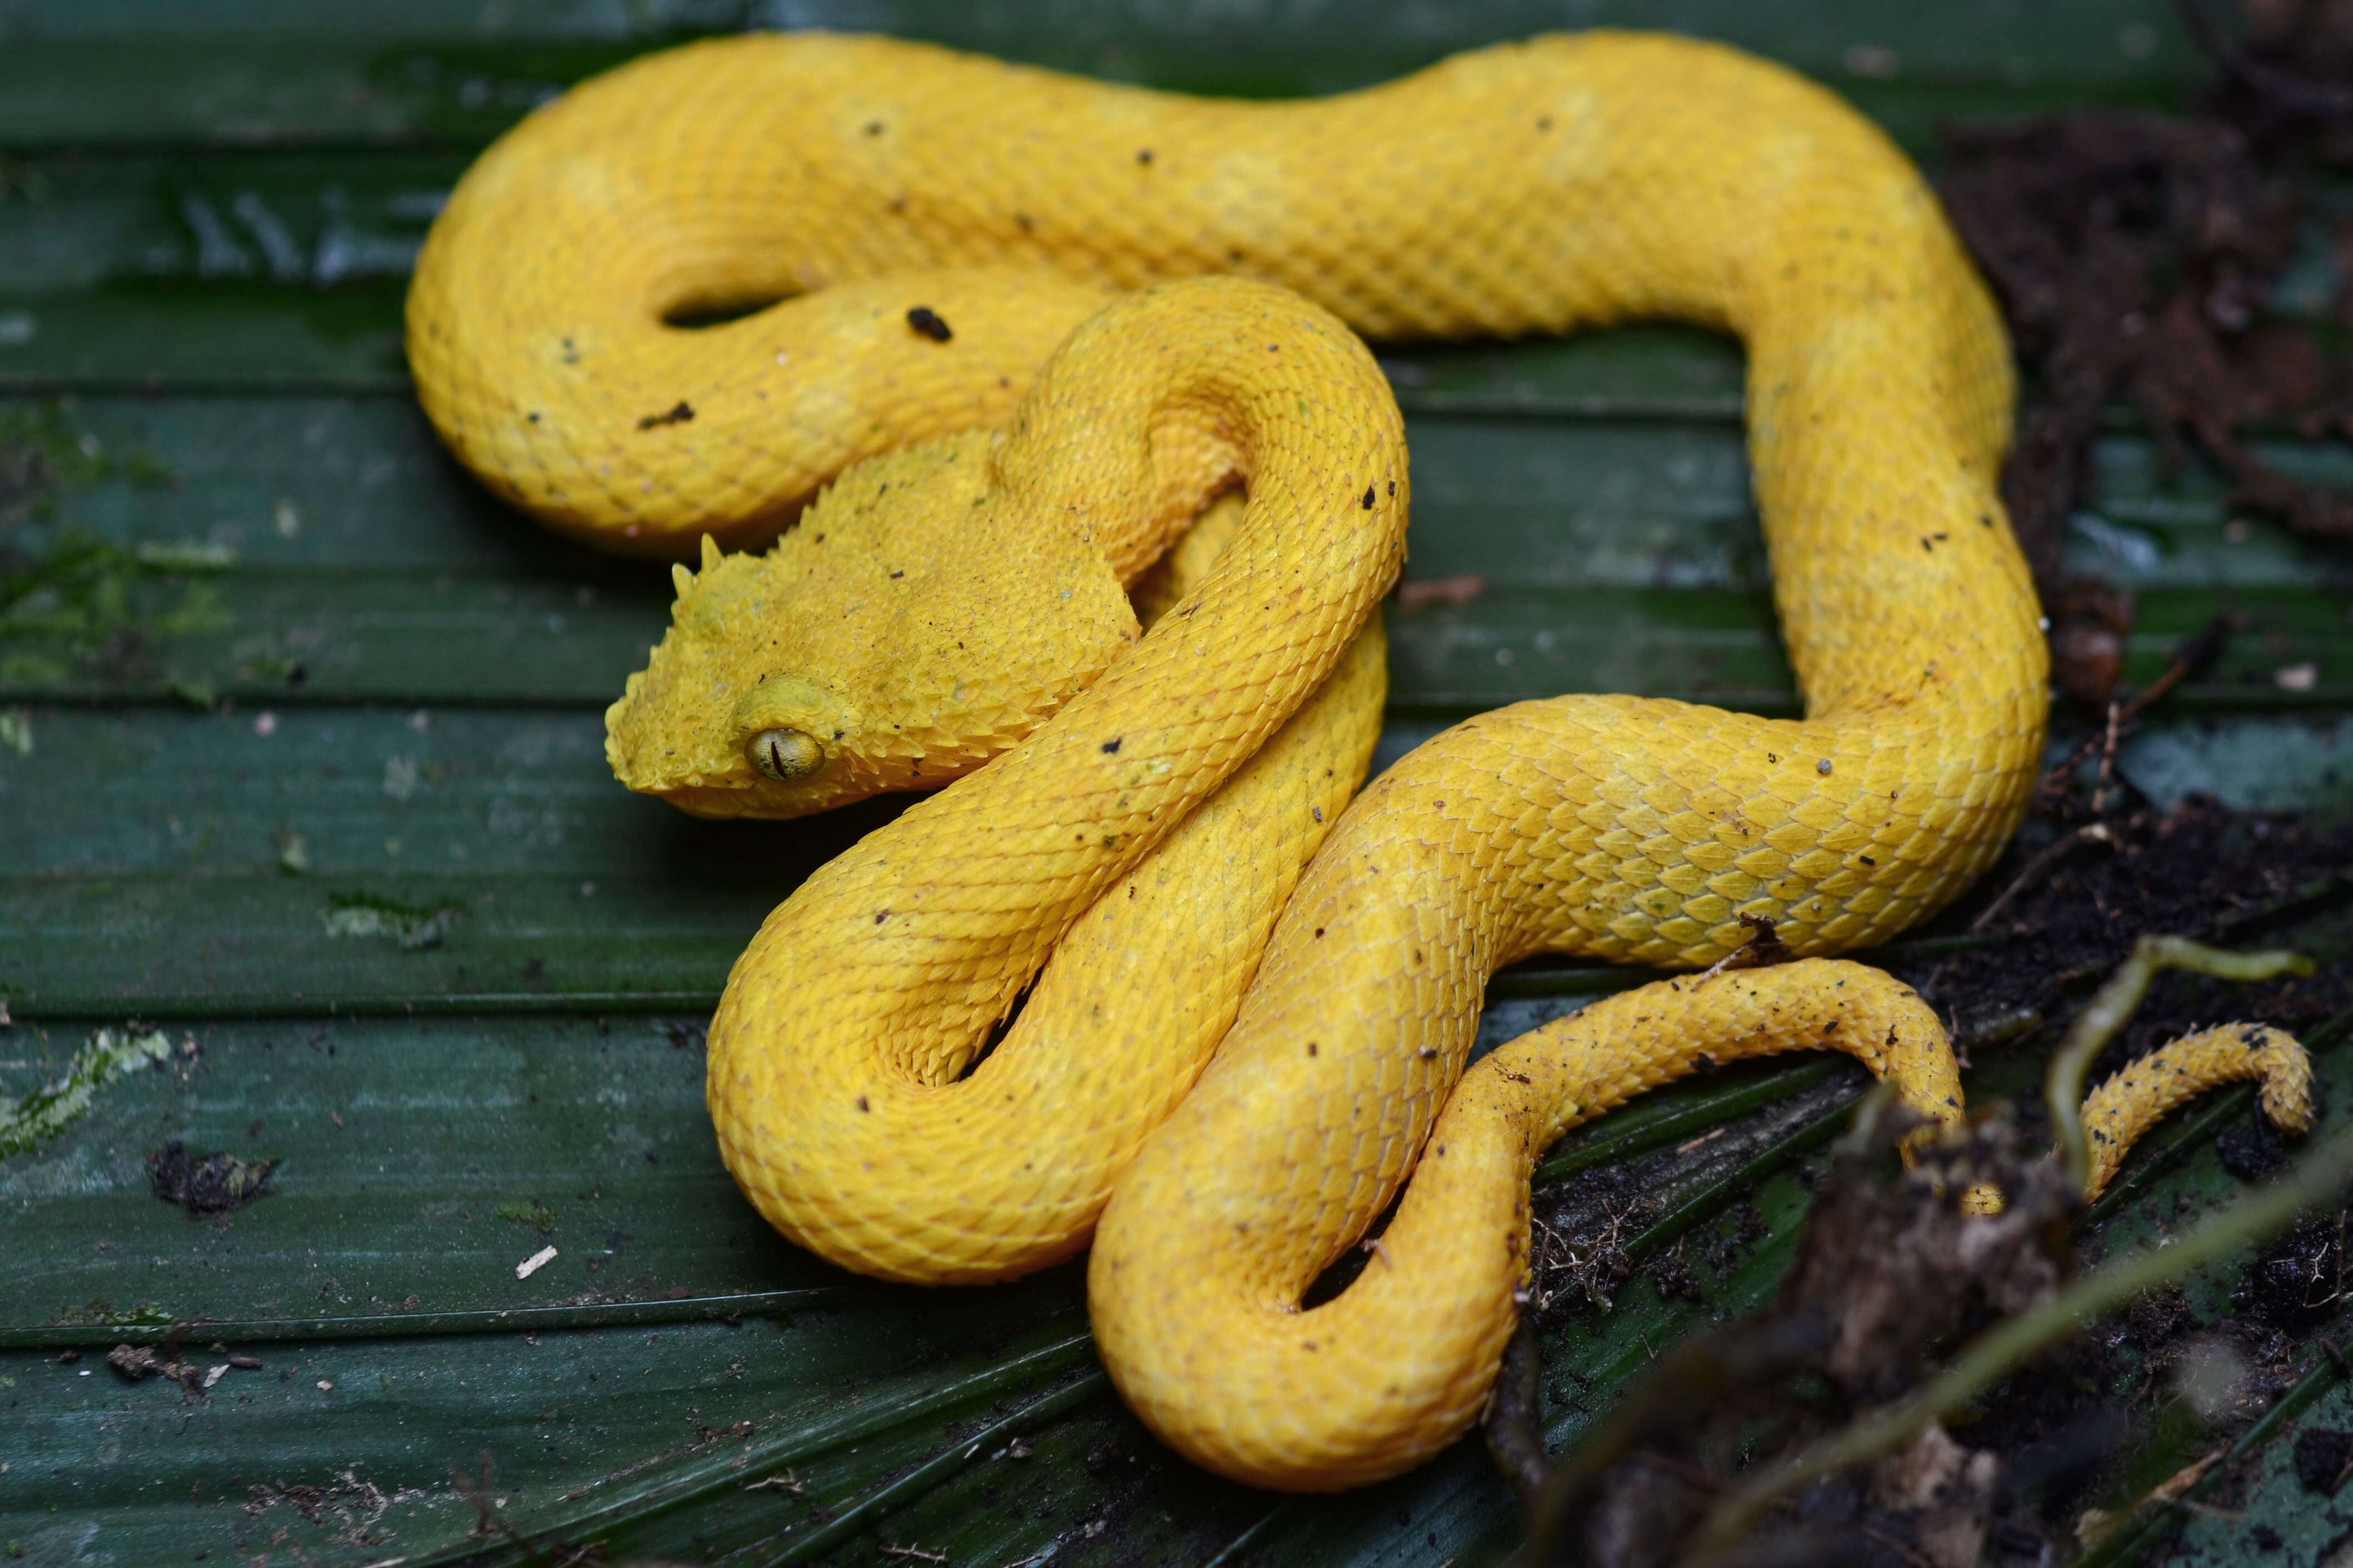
[706,280,1409,1283]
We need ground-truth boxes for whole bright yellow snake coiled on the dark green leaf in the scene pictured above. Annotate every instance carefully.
[409,33,2315,1488]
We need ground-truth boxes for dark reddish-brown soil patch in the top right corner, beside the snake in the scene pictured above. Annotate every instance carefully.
[1944,0,2353,703]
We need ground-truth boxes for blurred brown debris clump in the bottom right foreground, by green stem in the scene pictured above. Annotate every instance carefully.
[1506,1112,2078,1568]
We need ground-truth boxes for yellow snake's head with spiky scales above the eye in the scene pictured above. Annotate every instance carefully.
[605,432,1139,816]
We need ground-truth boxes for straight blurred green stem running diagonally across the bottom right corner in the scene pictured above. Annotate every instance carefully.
[1701,1126,2353,1549]
